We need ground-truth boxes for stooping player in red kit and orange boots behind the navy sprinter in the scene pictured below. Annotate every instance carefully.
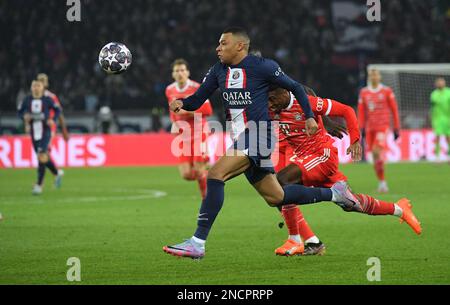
[269,88,421,256]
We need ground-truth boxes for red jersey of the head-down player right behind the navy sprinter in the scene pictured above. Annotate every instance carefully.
[271,94,359,157]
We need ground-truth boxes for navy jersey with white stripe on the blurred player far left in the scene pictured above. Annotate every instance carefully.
[19,95,61,140]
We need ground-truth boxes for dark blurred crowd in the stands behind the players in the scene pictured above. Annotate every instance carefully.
[0,0,450,123]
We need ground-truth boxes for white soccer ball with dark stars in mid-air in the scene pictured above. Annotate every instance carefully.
[98,42,132,74]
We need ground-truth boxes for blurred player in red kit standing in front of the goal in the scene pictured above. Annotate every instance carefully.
[358,69,400,193]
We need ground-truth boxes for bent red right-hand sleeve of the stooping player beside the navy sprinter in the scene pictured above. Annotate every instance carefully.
[309,98,360,144]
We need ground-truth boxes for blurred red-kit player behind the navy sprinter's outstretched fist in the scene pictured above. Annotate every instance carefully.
[166,58,212,198]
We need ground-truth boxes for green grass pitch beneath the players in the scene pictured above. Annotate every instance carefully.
[0,163,450,284]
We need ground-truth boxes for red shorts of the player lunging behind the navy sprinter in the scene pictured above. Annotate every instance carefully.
[290,146,347,187]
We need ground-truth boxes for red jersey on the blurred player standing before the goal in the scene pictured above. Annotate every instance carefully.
[358,84,400,131]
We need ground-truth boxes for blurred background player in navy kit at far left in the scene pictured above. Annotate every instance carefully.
[19,80,62,195]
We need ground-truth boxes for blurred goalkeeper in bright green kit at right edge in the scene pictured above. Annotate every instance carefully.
[430,77,450,160]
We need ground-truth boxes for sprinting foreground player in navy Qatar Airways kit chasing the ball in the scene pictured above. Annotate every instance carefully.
[163,28,358,258]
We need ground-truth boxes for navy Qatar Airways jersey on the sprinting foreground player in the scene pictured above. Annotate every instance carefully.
[179,55,314,138]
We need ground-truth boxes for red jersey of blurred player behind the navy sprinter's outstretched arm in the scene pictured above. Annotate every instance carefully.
[166,79,212,123]
